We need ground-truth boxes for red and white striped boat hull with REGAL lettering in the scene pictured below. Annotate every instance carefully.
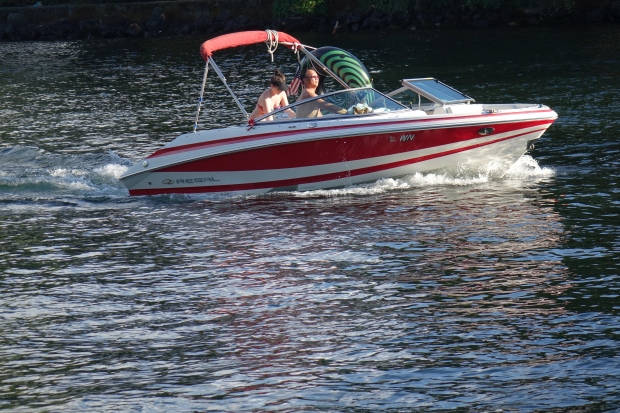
[121,108,557,195]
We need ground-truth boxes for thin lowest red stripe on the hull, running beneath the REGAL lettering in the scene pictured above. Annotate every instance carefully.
[129,128,550,196]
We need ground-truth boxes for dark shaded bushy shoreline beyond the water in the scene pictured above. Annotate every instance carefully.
[0,0,620,41]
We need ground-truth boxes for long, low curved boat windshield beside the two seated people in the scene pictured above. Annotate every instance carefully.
[255,87,409,122]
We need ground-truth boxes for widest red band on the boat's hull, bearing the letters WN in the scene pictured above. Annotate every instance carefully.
[157,120,553,172]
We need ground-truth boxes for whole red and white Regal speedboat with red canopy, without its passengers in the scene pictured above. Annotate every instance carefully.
[120,31,557,195]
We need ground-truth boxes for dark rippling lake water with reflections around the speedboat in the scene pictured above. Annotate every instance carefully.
[0,26,620,413]
